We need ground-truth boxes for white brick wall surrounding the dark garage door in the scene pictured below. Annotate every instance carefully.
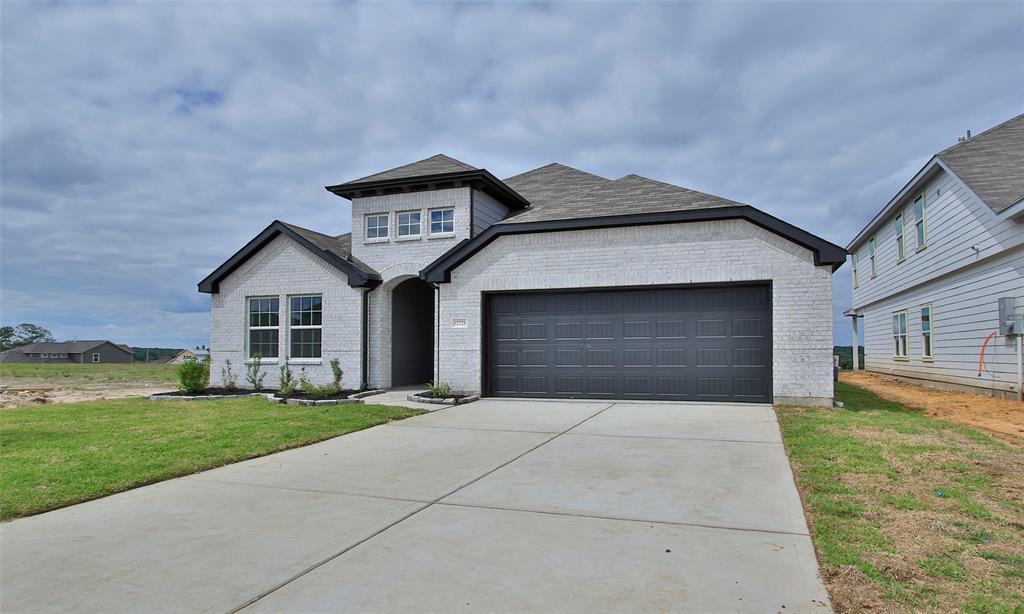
[438,220,833,404]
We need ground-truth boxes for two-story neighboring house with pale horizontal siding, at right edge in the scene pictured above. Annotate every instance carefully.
[847,115,1024,396]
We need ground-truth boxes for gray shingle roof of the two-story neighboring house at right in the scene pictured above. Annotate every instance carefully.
[937,115,1024,213]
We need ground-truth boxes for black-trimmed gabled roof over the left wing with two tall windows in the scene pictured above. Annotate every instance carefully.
[199,220,381,294]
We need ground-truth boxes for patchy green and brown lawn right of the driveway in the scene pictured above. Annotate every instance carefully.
[778,384,1024,613]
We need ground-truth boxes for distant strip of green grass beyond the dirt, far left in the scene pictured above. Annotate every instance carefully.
[0,362,177,386]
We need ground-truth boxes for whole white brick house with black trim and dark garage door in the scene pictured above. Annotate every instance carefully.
[199,156,846,404]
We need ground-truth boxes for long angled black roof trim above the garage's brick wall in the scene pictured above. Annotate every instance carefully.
[420,205,847,283]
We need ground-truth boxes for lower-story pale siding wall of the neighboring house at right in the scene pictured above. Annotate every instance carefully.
[863,248,1024,392]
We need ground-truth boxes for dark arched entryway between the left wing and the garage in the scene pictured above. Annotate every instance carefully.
[391,277,434,386]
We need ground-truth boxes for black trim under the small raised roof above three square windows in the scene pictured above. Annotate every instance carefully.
[326,169,529,210]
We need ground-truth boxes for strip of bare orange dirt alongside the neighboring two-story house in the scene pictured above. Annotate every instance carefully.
[840,371,1024,445]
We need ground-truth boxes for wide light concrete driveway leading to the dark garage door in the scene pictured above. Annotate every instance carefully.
[0,400,830,613]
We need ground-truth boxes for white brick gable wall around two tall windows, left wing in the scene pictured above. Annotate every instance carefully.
[210,235,362,388]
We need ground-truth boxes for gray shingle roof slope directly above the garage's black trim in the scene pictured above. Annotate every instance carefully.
[499,171,743,223]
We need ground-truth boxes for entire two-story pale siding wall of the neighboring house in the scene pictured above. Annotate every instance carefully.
[852,164,1024,392]
